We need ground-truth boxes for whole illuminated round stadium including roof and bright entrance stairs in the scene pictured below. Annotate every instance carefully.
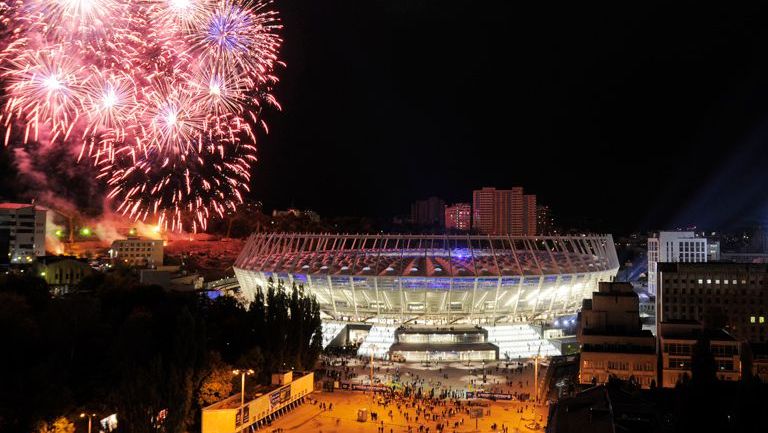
[234,233,619,360]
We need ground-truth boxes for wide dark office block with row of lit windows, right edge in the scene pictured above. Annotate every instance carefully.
[656,263,768,343]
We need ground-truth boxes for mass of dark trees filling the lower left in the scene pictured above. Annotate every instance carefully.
[0,270,321,433]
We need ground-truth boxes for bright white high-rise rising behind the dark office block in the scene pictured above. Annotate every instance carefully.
[648,232,709,296]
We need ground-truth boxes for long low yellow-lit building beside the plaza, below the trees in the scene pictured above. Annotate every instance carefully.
[201,372,315,433]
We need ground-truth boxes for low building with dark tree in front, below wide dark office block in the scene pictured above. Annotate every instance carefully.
[658,320,741,388]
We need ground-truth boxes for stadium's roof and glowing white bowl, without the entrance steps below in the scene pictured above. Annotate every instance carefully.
[234,233,619,324]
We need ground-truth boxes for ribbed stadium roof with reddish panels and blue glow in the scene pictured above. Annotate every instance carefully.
[235,233,618,277]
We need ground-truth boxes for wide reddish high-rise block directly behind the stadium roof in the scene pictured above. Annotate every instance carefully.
[472,187,536,236]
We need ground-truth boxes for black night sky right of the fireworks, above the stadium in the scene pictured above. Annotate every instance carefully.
[253,0,768,231]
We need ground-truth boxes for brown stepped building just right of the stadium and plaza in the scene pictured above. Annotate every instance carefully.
[578,282,657,388]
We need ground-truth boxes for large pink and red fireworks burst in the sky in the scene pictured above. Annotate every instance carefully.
[0,0,282,231]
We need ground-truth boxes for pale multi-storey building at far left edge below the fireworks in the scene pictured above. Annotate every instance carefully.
[0,203,47,263]
